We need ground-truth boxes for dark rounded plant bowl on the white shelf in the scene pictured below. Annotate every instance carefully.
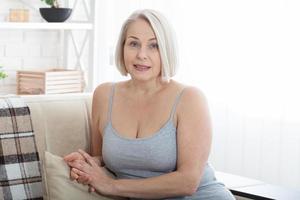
[40,8,72,22]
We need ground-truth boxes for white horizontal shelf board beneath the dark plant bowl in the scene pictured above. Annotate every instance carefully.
[0,22,93,30]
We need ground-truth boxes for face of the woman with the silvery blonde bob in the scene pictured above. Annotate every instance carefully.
[124,19,161,81]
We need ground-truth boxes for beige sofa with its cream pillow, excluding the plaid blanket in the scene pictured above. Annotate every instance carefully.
[0,93,245,200]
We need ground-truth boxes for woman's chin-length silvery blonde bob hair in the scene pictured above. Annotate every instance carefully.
[115,9,178,81]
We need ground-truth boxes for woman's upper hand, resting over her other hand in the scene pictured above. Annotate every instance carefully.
[68,149,114,195]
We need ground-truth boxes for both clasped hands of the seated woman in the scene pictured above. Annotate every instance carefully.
[64,149,114,195]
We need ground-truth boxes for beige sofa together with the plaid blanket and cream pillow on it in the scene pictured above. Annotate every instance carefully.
[0,93,119,200]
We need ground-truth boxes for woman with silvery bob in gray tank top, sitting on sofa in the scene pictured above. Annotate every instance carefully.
[65,10,234,200]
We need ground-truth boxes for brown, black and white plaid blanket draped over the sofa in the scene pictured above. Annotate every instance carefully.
[0,97,43,200]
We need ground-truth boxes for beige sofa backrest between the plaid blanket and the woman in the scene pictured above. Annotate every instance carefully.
[22,94,92,199]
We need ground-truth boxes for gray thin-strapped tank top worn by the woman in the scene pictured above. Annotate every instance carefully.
[102,85,219,198]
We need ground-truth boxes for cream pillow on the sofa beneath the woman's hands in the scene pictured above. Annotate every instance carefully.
[45,151,122,200]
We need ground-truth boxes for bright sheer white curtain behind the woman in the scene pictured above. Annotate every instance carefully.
[95,0,300,189]
